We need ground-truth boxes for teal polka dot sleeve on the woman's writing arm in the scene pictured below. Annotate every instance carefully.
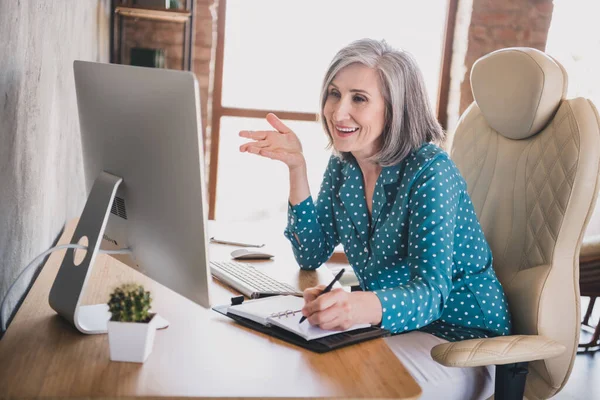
[374,157,465,333]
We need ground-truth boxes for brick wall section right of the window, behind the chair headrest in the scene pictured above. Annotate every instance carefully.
[459,0,553,114]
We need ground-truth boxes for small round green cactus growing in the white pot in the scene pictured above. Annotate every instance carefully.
[108,283,152,322]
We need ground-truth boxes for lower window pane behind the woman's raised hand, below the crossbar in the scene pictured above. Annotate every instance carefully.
[215,117,331,225]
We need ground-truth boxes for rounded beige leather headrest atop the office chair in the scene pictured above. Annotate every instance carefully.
[471,47,568,139]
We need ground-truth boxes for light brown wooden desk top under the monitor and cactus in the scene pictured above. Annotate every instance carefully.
[0,221,421,399]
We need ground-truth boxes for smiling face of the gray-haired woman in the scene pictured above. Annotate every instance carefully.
[323,63,385,160]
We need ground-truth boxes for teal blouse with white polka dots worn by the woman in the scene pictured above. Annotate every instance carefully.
[285,144,511,341]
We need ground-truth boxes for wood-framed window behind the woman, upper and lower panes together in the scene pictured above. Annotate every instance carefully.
[210,0,448,221]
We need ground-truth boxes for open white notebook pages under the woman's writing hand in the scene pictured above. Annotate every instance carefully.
[227,296,371,340]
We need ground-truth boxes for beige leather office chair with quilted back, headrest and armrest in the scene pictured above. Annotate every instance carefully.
[431,48,600,400]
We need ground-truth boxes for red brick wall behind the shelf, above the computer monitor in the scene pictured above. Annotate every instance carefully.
[122,0,218,137]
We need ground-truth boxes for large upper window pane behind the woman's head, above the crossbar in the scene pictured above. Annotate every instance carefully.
[223,0,448,113]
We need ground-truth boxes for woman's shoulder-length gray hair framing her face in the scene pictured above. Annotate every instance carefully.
[320,39,445,167]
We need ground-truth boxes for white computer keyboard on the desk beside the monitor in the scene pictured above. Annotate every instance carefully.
[210,261,302,299]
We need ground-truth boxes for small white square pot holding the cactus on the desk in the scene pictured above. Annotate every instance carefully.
[108,314,156,363]
